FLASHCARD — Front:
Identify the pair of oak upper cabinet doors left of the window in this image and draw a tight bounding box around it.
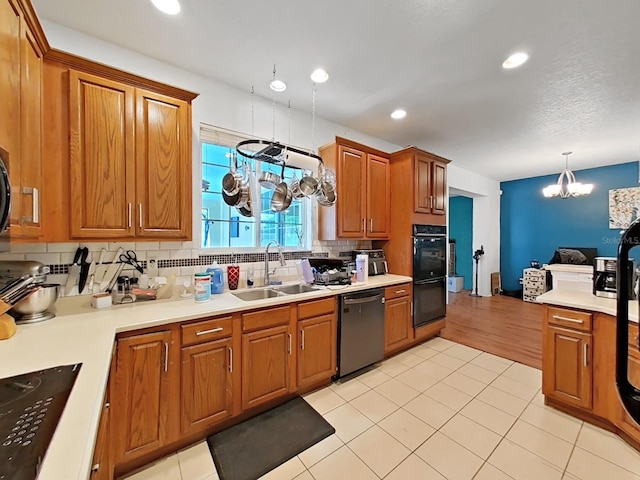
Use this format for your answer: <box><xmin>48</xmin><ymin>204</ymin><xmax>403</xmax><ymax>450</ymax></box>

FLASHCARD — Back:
<box><xmin>69</xmin><ymin>70</ymin><xmax>191</xmax><ymax>239</ymax></box>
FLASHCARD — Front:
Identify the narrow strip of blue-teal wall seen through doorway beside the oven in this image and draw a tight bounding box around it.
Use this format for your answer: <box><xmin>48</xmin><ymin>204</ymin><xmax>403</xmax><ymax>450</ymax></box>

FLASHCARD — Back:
<box><xmin>449</xmin><ymin>197</ymin><xmax>473</xmax><ymax>290</ymax></box>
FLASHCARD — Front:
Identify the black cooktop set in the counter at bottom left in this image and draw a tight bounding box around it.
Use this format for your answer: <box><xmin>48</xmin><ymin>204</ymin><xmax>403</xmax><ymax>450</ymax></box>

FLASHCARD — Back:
<box><xmin>0</xmin><ymin>363</ymin><xmax>82</xmax><ymax>480</ymax></box>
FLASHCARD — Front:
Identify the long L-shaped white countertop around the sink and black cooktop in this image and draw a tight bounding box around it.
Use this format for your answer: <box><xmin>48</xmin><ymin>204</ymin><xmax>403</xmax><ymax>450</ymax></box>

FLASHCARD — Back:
<box><xmin>0</xmin><ymin>274</ymin><xmax>412</xmax><ymax>480</ymax></box>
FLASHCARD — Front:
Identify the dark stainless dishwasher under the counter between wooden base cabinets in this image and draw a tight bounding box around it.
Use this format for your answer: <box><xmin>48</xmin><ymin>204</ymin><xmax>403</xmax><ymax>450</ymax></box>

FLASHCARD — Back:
<box><xmin>338</xmin><ymin>288</ymin><xmax>384</xmax><ymax>377</ymax></box>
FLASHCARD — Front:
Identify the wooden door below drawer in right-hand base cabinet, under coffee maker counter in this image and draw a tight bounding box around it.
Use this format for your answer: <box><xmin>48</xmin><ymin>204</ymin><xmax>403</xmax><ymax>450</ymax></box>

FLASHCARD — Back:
<box><xmin>542</xmin><ymin>326</ymin><xmax>593</xmax><ymax>409</ymax></box>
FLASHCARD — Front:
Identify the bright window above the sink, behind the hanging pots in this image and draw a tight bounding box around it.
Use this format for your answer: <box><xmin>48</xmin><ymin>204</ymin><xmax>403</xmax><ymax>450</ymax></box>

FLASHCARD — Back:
<box><xmin>200</xmin><ymin>125</ymin><xmax>311</xmax><ymax>248</ymax></box>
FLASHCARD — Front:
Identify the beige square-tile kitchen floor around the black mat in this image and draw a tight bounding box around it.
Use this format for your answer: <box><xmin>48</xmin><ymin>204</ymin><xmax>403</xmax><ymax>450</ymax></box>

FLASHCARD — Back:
<box><xmin>121</xmin><ymin>338</ymin><xmax>640</xmax><ymax>480</ymax></box>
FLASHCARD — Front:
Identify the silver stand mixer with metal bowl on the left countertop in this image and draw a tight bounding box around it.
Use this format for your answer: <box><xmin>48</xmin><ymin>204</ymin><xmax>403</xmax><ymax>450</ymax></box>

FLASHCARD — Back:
<box><xmin>0</xmin><ymin>260</ymin><xmax>60</xmax><ymax>323</ymax></box>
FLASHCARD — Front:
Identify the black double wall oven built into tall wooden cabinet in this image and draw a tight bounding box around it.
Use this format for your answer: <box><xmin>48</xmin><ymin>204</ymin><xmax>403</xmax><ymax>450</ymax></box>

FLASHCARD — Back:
<box><xmin>413</xmin><ymin>225</ymin><xmax>447</xmax><ymax>327</ymax></box>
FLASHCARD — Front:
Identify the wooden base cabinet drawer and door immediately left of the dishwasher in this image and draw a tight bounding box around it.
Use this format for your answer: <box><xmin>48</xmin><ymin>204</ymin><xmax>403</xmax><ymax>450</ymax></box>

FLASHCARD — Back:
<box><xmin>297</xmin><ymin>297</ymin><xmax>338</xmax><ymax>389</ymax></box>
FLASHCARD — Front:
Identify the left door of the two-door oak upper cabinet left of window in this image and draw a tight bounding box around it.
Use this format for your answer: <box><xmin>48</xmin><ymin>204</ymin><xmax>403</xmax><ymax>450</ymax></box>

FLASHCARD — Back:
<box><xmin>69</xmin><ymin>70</ymin><xmax>135</xmax><ymax>238</ymax></box>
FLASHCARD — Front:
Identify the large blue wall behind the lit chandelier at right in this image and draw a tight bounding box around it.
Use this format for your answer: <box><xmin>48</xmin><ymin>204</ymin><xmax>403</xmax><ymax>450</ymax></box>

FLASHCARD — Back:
<box><xmin>500</xmin><ymin>162</ymin><xmax>638</xmax><ymax>290</ymax></box>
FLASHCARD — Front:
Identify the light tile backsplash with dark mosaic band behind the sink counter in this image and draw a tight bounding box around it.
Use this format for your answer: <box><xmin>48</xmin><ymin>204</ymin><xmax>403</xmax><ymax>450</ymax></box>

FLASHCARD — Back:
<box><xmin>0</xmin><ymin>240</ymin><xmax>371</xmax><ymax>288</ymax></box>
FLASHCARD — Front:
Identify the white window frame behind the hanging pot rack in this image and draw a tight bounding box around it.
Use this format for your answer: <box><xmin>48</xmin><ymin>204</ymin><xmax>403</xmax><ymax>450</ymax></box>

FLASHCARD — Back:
<box><xmin>199</xmin><ymin>123</ymin><xmax>313</xmax><ymax>255</ymax></box>
